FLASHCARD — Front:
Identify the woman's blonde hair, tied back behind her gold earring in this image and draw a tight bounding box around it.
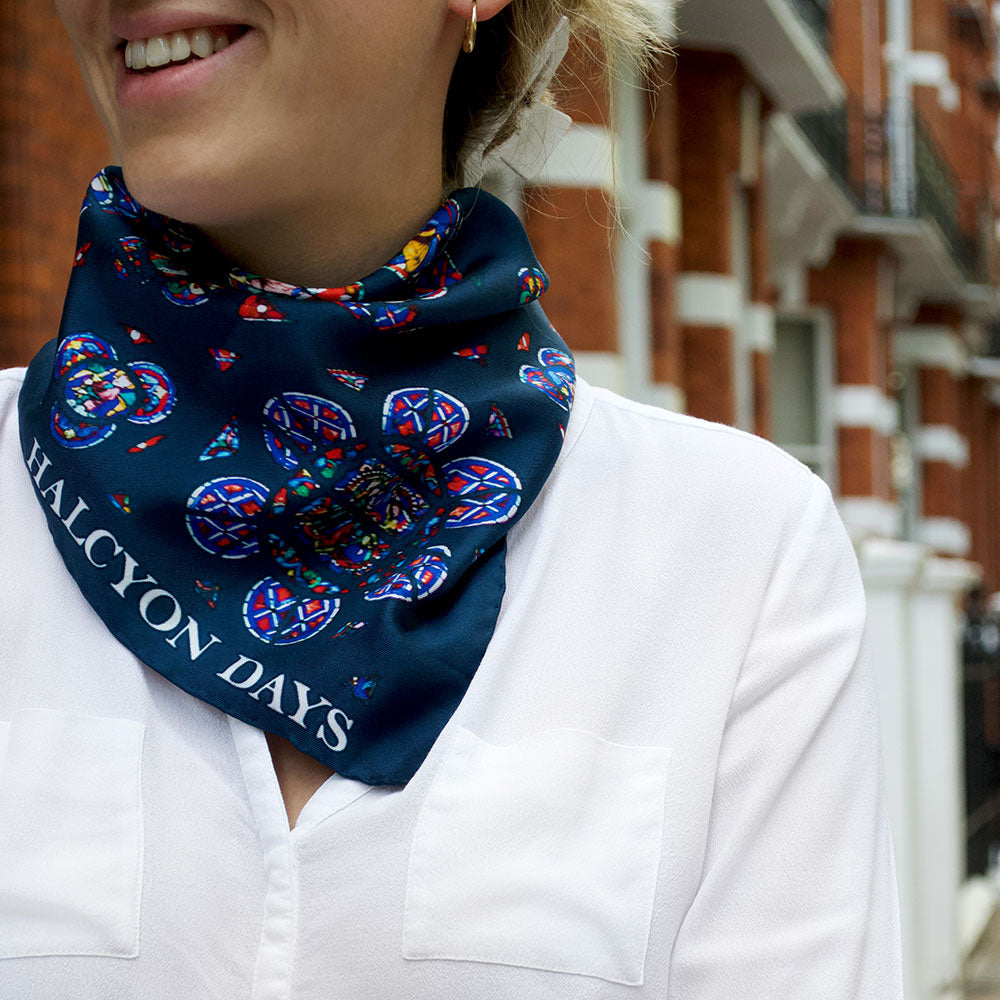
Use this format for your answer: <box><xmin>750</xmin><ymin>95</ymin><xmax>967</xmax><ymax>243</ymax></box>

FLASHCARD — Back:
<box><xmin>443</xmin><ymin>0</ymin><xmax>671</xmax><ymax>188</ymax></box>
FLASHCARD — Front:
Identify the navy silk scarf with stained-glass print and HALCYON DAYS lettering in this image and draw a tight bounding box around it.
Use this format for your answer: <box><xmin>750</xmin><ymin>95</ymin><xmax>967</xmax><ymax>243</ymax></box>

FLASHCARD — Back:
<box><xmin>19</xmin><ymin>167</ymin><xmax>575</xmax><ymax>785</ymax></box>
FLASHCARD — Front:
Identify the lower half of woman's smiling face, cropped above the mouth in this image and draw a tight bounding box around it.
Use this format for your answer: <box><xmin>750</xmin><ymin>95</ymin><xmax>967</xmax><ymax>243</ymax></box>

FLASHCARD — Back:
<box><xmin>56</xmin><ymin>0</ymin><xmax>478</xmax><ymax>226</ymax></box>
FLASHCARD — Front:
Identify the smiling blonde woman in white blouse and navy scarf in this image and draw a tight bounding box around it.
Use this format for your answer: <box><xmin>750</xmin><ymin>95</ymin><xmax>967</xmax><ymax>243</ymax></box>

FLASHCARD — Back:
<box><xmin>0</xmin><ymin>0</ymin><xmax>901</xmax><ymax>1000</ymax></box>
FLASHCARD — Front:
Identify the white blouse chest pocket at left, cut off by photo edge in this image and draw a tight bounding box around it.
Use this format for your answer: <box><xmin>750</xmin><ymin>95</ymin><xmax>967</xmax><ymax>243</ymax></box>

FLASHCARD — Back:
<box><xmin>0</xmin><ymin>709</ymin><xmax>143</xmax><ymax>958</ymax></box>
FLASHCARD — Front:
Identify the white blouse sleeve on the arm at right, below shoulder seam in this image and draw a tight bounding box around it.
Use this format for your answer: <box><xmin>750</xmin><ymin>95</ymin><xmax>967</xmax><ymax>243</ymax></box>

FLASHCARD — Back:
<box><xmin>668</xmin><ymin>479</ymin><xmax>903</xmax><ymax>1000</ymax></box>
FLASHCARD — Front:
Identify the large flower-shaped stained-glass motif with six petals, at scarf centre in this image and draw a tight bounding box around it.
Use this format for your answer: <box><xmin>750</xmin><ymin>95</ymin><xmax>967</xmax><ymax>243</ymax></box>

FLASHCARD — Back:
<box><xmin>187</xmin><ymin>387</ymin><xmax>522</xmax><ymax>645</ymax></box>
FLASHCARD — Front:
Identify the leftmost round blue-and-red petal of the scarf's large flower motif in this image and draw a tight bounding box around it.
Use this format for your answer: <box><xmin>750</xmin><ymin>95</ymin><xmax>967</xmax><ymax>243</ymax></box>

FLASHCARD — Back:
<box><xmin>186</xmin><ymin>476</ymin><xmax>268</xmax><ymax>559</ymax></box>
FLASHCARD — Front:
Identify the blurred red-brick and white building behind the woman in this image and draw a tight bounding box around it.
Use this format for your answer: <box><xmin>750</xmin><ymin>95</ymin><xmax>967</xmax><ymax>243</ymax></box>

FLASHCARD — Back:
<box><xmin>9</xmin><ymin>0</ymin><xmax>1000</xmax><ymax>1000</ymax></box>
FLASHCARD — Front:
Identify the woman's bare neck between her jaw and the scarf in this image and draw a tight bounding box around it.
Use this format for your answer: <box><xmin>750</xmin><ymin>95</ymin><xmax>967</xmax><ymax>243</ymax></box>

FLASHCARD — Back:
<box><xmin>192</xmin><ymin>158</ymin><xmax>446</xmax><ymax>288</ymax></box>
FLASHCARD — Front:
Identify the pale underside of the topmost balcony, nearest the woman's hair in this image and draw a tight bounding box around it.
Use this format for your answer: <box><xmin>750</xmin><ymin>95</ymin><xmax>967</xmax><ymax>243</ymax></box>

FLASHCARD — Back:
<box><xmin>677</xmin><ymin>0</ymin><xmax>844</xmax><ymax>112</ymax></box>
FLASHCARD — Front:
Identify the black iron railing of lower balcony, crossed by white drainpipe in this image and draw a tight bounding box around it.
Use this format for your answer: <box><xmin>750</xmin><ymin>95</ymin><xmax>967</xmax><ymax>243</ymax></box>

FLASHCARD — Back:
<box><xmin>796</xmin><ymin>100</ymin><xmax>986</xmax><ymax>281</ymax></box>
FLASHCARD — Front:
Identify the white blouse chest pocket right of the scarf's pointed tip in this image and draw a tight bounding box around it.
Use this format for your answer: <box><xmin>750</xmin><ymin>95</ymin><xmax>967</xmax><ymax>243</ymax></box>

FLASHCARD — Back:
<box><xmin>403</xmin><ymin>727</ymin><xmax>671</xmax><ymax>985</ymax></box>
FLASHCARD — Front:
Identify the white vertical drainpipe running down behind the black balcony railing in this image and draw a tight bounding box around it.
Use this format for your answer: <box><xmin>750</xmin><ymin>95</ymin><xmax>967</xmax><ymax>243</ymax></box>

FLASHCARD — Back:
<box><xmin>885</xmin><ymin>0</ymin><xmax>916</xmax><ymax>216</ymax></box>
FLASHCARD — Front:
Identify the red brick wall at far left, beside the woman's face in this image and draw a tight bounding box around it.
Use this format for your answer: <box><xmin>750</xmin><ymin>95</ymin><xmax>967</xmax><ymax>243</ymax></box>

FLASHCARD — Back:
<box><xmin>0</xmin><ymin>0</ymin><xmax>110</xmax><ymax>367</ymax></box>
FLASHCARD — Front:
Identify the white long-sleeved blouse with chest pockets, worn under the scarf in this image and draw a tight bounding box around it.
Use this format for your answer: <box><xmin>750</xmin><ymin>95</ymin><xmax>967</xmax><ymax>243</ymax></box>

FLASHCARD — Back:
<box><xmin>0</xmin><ymin>371</ymin><xmax>902</xmax><ymax>1000</ymax></box>
